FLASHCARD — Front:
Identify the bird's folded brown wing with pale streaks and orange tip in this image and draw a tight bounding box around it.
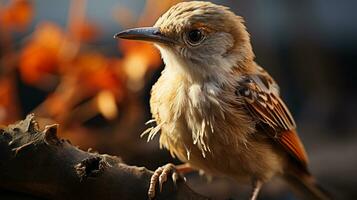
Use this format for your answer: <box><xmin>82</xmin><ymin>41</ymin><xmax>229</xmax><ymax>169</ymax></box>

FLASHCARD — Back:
<box><xmin>236</xmin><ymin>70</ymin><xmax>308</xmax><ymax>168</ymax></box>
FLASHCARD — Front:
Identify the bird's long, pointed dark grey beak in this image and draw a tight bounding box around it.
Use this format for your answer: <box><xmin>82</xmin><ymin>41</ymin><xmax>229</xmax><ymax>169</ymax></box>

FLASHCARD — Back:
<box><xmin>114</xmin><ymin>27</ymin><xmax>176</xmax><ymax>44</ymax></box>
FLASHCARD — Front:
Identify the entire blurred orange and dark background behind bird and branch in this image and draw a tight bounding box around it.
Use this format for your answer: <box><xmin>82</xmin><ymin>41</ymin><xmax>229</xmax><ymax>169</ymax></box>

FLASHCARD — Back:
<box><xmin>0</xmin><ymin>0</ymin><xmax>357</xmax><ymax>199</ymax></box>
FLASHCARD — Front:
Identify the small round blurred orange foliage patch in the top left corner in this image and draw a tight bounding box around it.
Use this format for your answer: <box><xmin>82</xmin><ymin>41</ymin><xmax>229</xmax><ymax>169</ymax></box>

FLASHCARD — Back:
<box><xmin>0</xmin><ymin>0</ymin><xmax>34</xmax><ymax>30</ymax></box>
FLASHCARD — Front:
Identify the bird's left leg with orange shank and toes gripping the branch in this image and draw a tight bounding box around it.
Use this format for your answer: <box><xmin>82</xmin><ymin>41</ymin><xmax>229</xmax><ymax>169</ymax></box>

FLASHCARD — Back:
<box><xmin>148</xmin><ymin>163</ymin><xmax>193</xmax><ymax>199</ymax></box>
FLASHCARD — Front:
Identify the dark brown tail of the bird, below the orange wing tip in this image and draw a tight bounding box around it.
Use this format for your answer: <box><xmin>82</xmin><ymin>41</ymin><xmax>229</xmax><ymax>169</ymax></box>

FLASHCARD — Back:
<box><xmin>284</xmin><ymin>173</ymin><xmax>333</xmax><ymax>200</ymax></box>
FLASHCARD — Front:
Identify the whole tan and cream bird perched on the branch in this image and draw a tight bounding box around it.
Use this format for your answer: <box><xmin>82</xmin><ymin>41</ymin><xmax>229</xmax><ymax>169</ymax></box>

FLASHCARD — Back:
<box><xmin>114</xmin><ymin>1</ymin><xmax>330</xmax><ymax>200</ymax></box>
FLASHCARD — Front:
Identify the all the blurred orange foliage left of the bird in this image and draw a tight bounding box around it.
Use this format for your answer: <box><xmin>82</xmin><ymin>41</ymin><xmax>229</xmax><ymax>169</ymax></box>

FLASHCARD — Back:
<box><xmin>0</xmin><ymin>0</ymin><xmax>172</xmax><ymax>134</ymax></box>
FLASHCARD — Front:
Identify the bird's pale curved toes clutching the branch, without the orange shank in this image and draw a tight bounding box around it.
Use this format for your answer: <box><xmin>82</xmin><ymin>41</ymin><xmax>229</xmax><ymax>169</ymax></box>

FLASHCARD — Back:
<box><xmin>148</xmin><ymin>163</ymin><xmax>181</xmax><ymax>200</ymax></box>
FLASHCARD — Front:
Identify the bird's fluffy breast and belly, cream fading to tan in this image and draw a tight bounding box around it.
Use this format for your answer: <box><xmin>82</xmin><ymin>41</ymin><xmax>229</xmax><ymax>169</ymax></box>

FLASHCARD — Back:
<box><xmin>150</xmin><ymin>72</ymin><xmax>280</xmax><ymax>181</ymax></box>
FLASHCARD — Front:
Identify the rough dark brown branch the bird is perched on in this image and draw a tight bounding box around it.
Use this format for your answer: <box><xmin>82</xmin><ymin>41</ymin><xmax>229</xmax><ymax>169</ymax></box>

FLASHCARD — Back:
<box><xmin>0</xmin><ymin>115</ymin><xmax>207</xmax><ymax>200</ymax></box>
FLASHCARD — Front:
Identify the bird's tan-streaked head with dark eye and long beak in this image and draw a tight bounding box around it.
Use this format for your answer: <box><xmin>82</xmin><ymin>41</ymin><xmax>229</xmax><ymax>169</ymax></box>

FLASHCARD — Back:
<box><xmin>115</xmin><ymin>1</ymin><xmax>254</xmax><ymax>80</ymax></box>
